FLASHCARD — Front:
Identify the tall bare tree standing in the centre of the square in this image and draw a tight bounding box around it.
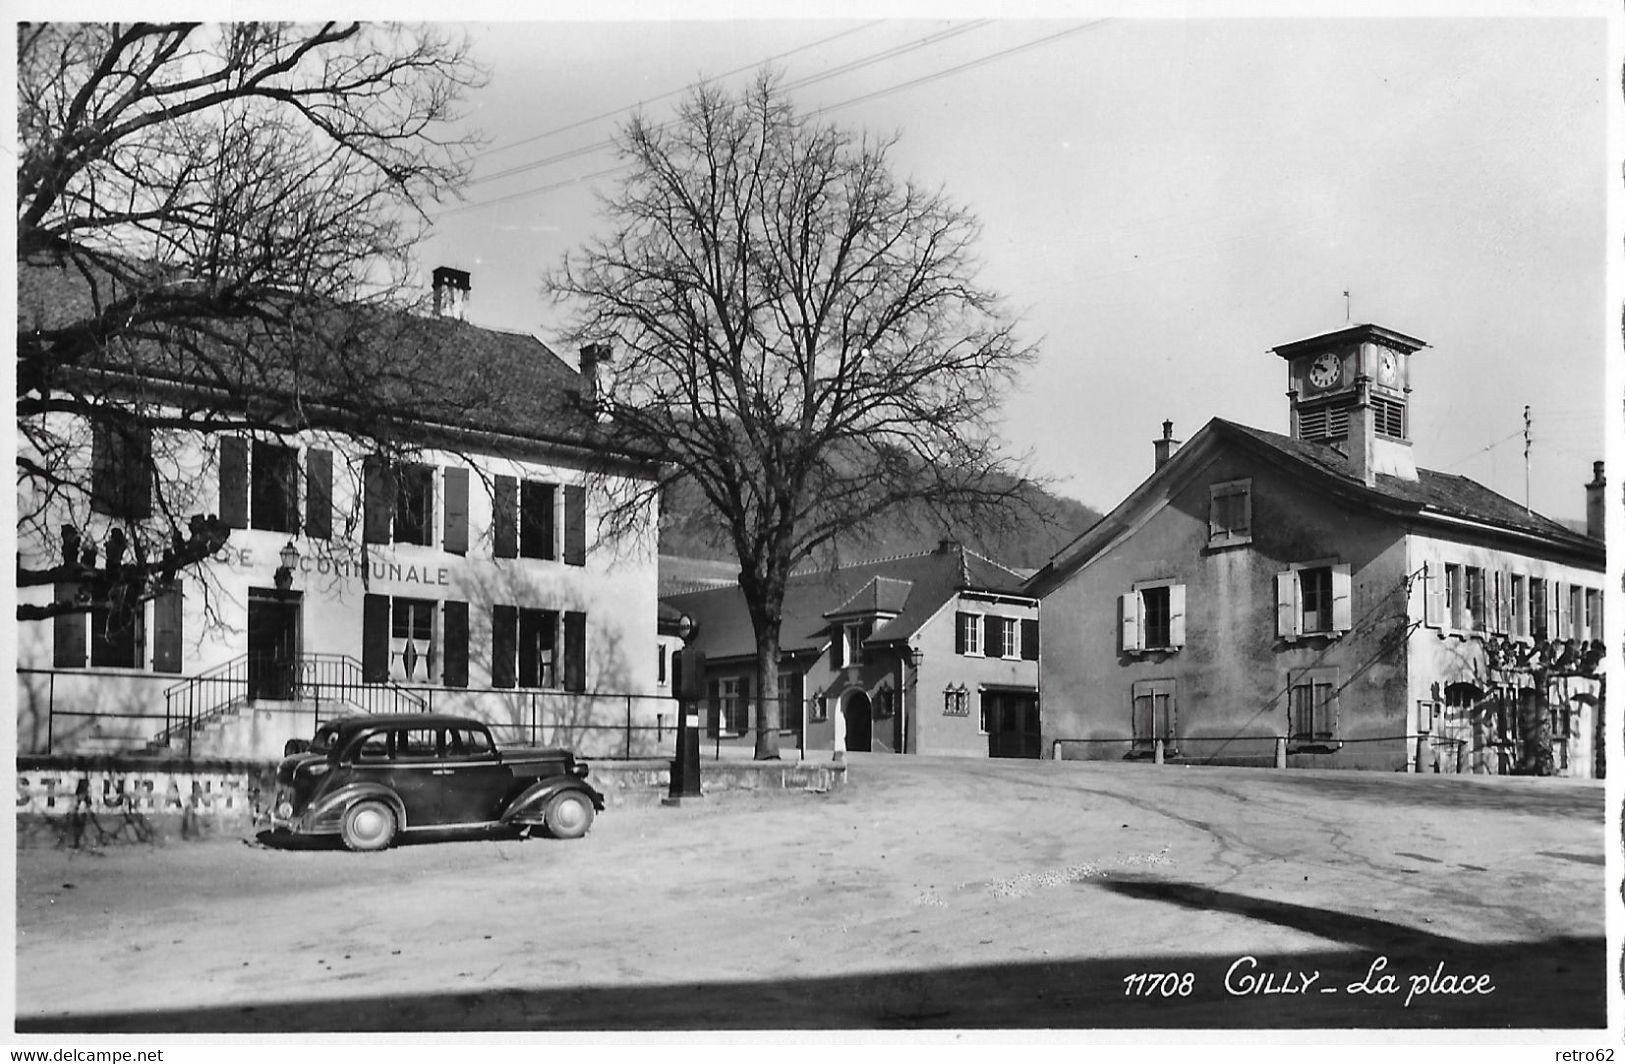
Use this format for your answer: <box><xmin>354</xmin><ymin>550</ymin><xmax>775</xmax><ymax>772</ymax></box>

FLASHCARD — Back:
<box><xmin>548</xmin><ymin>71</ymin><xmax>1032</xmax><ymax>759</ymax></box>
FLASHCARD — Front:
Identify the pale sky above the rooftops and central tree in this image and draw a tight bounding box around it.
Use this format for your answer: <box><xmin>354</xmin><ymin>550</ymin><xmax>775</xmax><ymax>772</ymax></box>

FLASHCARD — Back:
<box><xmin>409</xmin><ymin>3</ymin><xmax>1619</xmax><ymax>518</ymax></box>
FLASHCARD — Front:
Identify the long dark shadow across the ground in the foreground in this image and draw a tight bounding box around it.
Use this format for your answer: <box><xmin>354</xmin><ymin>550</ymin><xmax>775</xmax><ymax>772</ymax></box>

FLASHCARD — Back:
<box><xmin>16</xmin><ymin>879</ymin><xmax>1607</xmax><ymax>1033</ymax></box>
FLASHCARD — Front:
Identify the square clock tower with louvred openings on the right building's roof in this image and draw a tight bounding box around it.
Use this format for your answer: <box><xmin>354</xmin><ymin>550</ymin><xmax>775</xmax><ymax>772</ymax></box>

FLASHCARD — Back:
<box><xmin>1274</xmin><ymin>325</ymin><xmax>1427</xmax><ymax>484</ymax></box>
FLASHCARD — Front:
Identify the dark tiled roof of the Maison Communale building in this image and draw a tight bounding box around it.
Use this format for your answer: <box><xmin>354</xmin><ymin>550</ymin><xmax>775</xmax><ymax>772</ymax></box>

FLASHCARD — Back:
<box><xmin>18</xmin><ymin>253</ymin><xmax>630</xmax><ymax>447</ymax></box>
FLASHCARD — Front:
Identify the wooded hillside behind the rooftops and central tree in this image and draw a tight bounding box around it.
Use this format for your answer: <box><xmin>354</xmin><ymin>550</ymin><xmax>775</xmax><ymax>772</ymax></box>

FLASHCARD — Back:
<box><xmin>660</xmin><ymin>481</ymin><xmax>1102</xmax><ymax>572</ymax></box>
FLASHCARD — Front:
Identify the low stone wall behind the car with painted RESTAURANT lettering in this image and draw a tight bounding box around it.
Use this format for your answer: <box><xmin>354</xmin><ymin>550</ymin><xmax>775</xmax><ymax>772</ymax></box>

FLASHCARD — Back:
<box><xmin>16</xmin><ymin>755</ymin><xmax>847</xmax><ymax>846</ymax></box>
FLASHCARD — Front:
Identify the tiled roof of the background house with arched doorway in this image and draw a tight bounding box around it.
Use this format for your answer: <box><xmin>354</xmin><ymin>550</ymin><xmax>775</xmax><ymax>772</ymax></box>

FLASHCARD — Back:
<box><xmin>663</xmin><ymin>546</ymin><xmax>1022</xmax><ymax>658</ymax></box>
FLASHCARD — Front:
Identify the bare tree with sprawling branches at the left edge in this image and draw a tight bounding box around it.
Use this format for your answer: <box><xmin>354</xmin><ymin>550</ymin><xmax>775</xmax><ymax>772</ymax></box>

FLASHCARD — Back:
<box><xmin>16</xmin><ymin>23</ymin><xmax>483</xmax><ymax>619</ymax></box>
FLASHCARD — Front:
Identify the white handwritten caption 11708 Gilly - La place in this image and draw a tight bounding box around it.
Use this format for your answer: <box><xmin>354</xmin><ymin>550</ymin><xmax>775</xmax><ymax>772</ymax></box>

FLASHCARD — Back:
<box><xmin>1123</xmin><ymin>955</ymin><xmax>1495</xmax><ymax>1009</ymax></box>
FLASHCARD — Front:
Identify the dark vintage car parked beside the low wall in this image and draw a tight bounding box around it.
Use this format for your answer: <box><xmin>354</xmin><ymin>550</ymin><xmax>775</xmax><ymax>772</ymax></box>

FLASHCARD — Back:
<box><xmin>271</xmin><ymin>713</ymin><xmax>605</xmax><ymax>850</ymax></box>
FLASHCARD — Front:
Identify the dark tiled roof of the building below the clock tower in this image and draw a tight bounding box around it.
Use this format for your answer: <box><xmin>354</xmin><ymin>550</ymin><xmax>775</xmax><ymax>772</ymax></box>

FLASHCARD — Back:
<box><xmin>1209</xmin><ymin>417</ymin><xmax>1602</xmax><ymax>549</ymax></box>
